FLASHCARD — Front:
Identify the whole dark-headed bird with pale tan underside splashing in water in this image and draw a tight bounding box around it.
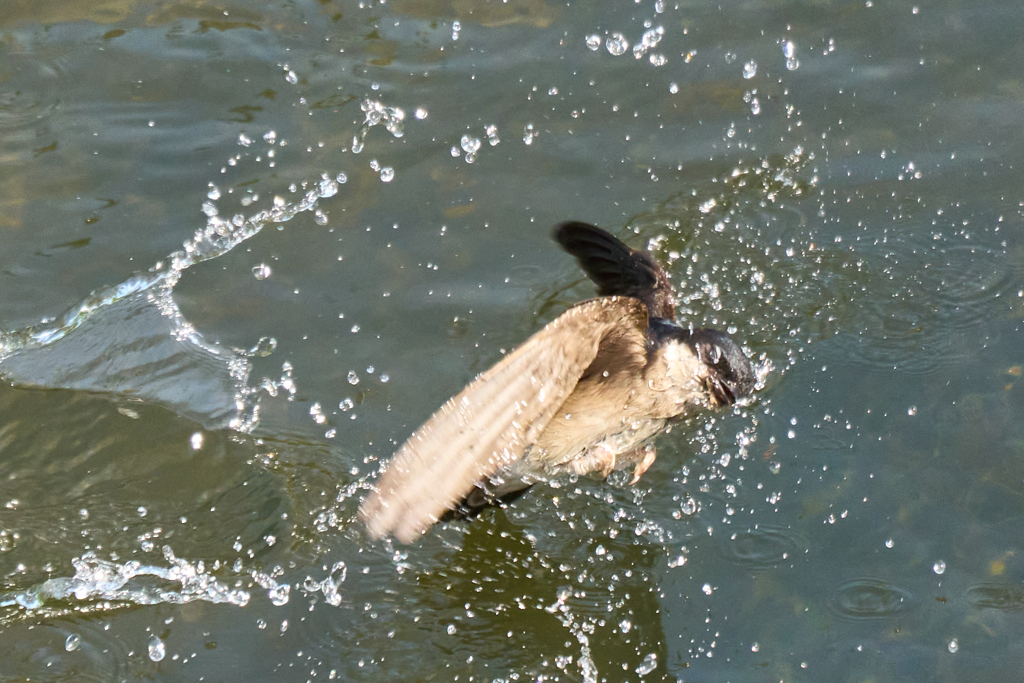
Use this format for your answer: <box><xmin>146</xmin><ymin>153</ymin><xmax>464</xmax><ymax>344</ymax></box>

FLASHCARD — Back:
<box><xmin>359</xmin><ymin>221</ymin><xmax>756</xmax><ymax>544</ymax></box>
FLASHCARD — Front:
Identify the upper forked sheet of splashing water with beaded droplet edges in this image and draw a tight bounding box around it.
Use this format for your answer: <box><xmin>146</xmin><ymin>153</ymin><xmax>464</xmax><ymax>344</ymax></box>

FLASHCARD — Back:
<box><xmin>0</xmin><ymin>164</ymin><xmax>344</xmax><ymax>432</ymax></box>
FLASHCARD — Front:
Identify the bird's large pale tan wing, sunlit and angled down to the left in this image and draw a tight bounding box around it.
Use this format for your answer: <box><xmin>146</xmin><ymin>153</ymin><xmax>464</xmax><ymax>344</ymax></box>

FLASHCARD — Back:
<box><xmin>359</xmin><ymin>297</ymin><xmax>647</xmax><ymax>543</ymax></box>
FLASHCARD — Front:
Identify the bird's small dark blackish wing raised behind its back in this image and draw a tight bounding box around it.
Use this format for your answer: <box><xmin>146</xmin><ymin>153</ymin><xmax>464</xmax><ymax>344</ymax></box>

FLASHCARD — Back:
<box><xmin>554</xmin><ymin>220</ymin><xmax>676</xmax><ymax>321</ymax></box>
